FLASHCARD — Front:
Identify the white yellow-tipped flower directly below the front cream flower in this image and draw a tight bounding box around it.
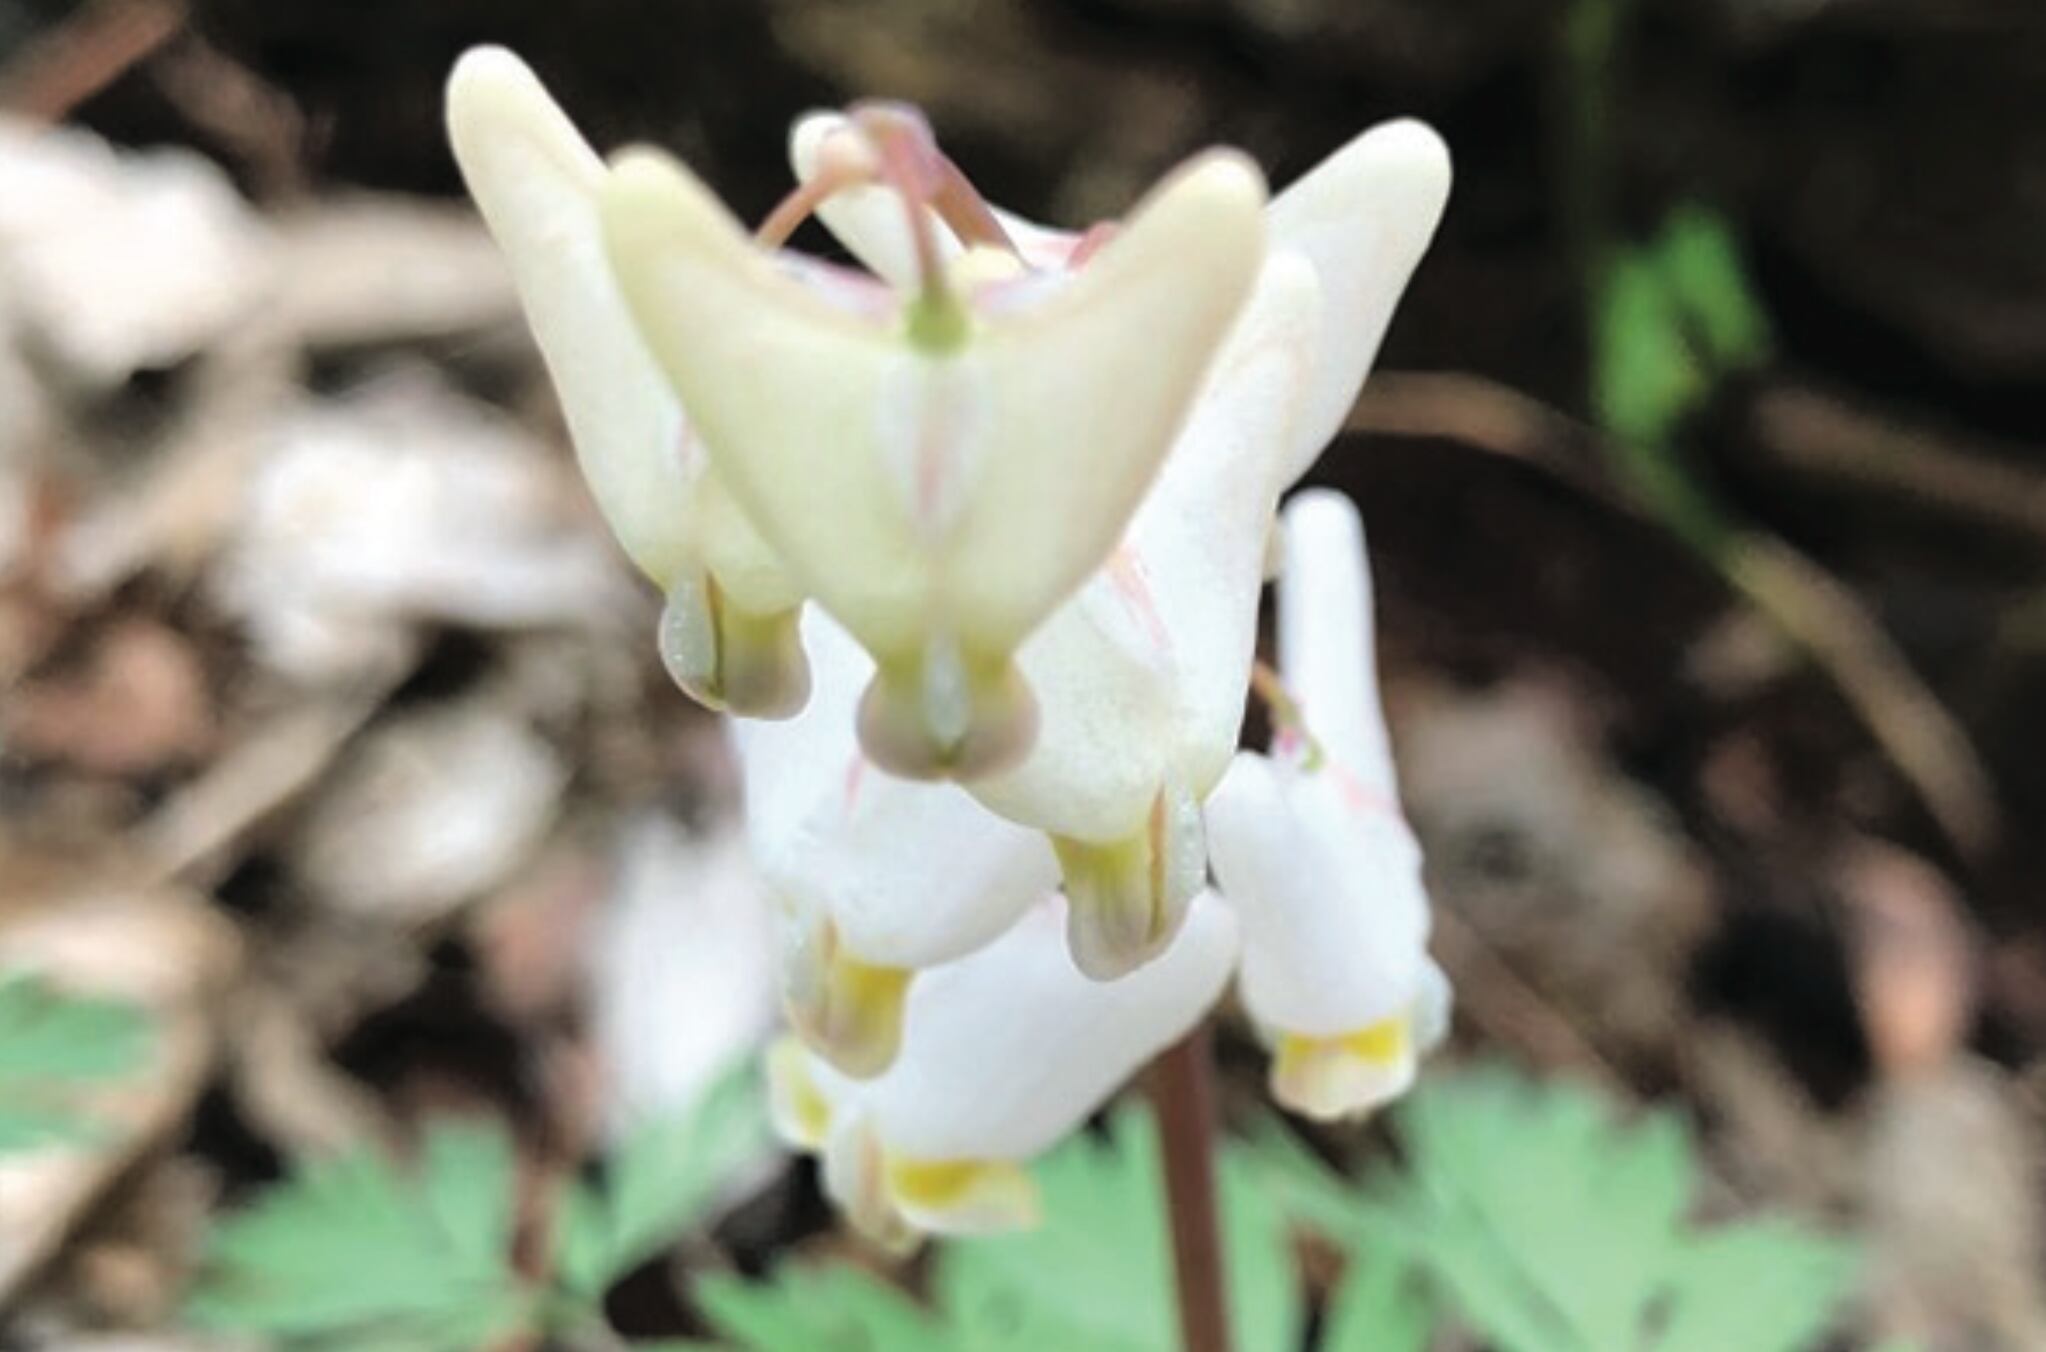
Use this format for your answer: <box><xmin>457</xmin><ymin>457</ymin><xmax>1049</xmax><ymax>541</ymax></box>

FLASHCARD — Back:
<box><xmin>732</xmin><ymin>610</ymin><xmax>1058</xmax><ymax>1076</ymax></box>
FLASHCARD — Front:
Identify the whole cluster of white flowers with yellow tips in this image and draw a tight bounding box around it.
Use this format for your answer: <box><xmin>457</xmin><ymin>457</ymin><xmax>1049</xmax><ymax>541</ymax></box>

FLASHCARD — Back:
<box><xmin>448</xmin><ymin>49</ymin><xmax>1449</xmax><ymax>1242</ymax></box>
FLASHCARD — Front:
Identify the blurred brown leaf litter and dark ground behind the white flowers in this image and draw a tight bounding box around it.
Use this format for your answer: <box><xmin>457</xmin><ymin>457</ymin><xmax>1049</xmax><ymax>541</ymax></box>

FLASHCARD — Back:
<box><xmin>0</xmin><ymin>0</ymin><xmax>2046</xmax><ymax>1352</ymax></box>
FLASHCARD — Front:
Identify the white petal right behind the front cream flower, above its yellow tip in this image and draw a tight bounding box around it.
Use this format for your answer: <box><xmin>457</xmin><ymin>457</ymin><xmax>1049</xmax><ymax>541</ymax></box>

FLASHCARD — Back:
<box><xmin>972</xmin><ymin>256</ymin><xmax>1318</xmax><ymax>841</ymax></box>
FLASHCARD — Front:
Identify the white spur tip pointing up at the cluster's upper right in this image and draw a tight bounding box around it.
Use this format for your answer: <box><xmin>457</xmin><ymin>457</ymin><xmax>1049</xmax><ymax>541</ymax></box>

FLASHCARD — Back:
<box><xmin>1271</xmin><ymin>121</ymin><xmax>1451</xmax><ymax>483</ymax></box>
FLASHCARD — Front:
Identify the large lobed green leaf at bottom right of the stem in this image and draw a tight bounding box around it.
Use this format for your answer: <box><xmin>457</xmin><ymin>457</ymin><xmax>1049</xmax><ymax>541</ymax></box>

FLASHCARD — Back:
<box><xmin>1256</xmin><ymin>1070</ymin><xmax>1854</xmax><ymax>1352</ymax></box>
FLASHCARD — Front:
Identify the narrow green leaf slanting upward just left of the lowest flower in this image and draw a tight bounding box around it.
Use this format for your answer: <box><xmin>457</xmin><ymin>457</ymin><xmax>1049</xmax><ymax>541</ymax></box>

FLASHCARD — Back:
<box><xmin>557</xmin><ymin>1066</ymin><xmax>767</xmax><ymax>1297</ymax></box>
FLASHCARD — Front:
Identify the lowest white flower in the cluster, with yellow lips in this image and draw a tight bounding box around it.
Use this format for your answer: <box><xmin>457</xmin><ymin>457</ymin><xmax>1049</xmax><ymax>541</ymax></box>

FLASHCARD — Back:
<box><xmin>769</xmin><ymin>896</ymin><xmax>1236</xmax><ymax>1246</ymax></box>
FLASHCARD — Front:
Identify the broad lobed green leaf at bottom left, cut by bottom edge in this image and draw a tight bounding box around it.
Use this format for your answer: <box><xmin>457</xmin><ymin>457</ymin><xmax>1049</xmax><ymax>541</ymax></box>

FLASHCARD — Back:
<box><xmin>186</xmin><ymin>1123</ymin><xmax>538</xmax><ymax>1352</ymax></box>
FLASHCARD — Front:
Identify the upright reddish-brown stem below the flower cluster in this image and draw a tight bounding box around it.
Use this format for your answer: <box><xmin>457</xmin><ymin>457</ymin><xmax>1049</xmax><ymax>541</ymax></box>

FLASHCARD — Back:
<box><xmin>1150</xmin><ymin>1025</ymin><xmax>1230</xmax><ymax>1352</ymax></box>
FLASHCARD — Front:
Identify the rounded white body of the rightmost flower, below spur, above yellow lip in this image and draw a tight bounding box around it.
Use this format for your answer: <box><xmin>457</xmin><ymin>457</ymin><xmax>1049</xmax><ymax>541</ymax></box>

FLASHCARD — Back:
<box><xmin>1207</xmin><ymin>753</ymin><xmax>1428</xmax><ymax>1037</ymax></box>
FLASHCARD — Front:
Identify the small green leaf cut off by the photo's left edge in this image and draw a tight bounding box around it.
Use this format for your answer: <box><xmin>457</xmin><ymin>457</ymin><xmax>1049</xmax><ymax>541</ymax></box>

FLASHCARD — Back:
<box><xmin>0</xmin><ymin>974</ymin><xmax>149</xmax><ymax>1154</ymax></box>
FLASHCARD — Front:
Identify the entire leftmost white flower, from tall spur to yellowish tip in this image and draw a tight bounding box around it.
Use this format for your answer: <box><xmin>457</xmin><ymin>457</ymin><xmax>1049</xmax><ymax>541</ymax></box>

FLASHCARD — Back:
<box><xmin>448</xmin><ymin>47</ymin><xmax>808</xmax><ymax>718</ymax></box>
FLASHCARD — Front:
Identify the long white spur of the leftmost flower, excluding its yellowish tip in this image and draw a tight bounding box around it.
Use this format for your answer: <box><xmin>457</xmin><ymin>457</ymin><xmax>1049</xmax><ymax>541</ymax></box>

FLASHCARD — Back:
<box><xmin>448</xmin><ymin>47</ymin><xmax>702</xmax><ymax>587</ymax></box>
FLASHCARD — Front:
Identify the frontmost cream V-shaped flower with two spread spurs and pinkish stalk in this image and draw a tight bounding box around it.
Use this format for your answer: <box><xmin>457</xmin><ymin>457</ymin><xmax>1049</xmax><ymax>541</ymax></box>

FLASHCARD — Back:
<box><xmin>599</xmin><ymin>108</ymin><xmax>1264</xmax><ymax>779</ymax></box>
